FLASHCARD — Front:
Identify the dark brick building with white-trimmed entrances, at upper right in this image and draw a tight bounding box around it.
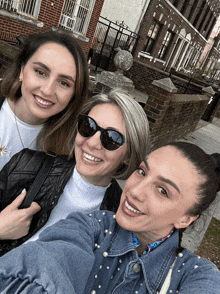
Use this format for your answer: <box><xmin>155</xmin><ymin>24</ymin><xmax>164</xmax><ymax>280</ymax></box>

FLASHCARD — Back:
<box><xmin>135</xmin><ymin>0</ymin><xmax>220</xmax><ymax>72</ymax></box>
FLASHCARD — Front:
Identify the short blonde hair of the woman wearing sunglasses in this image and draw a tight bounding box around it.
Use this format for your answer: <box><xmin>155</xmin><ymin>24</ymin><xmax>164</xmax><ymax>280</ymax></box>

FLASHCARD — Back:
<box><xmin>71</xmin><ymin>89</ymin><xmax>150</xmax><ymax>180</ymax></box>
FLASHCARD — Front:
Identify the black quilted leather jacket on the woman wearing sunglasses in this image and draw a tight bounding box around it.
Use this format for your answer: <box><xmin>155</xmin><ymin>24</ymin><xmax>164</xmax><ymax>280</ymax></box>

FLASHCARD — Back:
<box><xmin>0</xmin><ymin>149</ymin><xmax>122</xmax><ymax>256</ymax></box>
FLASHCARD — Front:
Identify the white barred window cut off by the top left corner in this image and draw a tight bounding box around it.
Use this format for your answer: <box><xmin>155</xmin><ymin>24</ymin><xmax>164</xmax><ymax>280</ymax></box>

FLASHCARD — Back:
<box><xmin>0</xmin><ymin>0</ymin><xmax>41</xmax><ymax>18</ymax></box>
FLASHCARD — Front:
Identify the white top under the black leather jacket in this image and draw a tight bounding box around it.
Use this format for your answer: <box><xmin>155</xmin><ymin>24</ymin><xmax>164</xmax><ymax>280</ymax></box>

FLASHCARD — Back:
<box><xmin>25</xmin><ymin>168</ymin><xmax>111</xmax><ymax>243</ymax></box>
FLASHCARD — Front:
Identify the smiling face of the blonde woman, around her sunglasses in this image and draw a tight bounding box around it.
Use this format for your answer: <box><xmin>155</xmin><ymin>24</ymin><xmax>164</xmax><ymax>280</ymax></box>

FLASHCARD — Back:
<box><xmin>75</xmin><ymin>103</ymin><xmax>127</xmax><ymax>187</ymax></box>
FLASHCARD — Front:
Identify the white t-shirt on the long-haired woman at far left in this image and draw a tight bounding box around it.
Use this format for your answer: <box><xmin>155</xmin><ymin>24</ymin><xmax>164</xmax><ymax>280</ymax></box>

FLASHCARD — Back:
<box><xmin>0</xmin><ymin>99</ymin><xmax>43</xmax><ymax>170</ymax></box>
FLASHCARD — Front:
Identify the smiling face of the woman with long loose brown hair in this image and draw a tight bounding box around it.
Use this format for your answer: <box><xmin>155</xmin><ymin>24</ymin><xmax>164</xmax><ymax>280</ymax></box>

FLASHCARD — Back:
<box><xmin>15</xmin><ymin>43</ymin><xmax>76</xmax><ymax>124</ymax></box>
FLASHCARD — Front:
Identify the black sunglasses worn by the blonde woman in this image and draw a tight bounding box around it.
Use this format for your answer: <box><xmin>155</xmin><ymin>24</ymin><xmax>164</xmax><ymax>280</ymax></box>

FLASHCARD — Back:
<box><xmin>78</xmin><ymin>114</ymin><xmax>125</xmax><ymax>151</ymax></box>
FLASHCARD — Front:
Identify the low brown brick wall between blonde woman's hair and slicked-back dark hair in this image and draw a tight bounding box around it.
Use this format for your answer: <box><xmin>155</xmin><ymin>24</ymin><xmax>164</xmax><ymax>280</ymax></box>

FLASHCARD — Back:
<box><xmin>144</xmin><ymin>78</ymin><xmax>210</xmax><ymax>150</ymax></box>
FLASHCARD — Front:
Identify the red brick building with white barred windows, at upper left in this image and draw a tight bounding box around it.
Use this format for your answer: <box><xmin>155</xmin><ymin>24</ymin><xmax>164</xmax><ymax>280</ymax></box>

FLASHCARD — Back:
<box><xmin>0</xmin><ymin>0</ymin><xmax>104</xmax><ymax>53</ymax></box>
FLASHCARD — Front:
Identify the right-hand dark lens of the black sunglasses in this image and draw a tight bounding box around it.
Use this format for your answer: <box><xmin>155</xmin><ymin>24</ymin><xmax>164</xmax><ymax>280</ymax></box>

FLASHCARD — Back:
<box><xmin>101</xmin><ymin>130</ymin><xmax>124</xmax><ymax>150</ymax></box>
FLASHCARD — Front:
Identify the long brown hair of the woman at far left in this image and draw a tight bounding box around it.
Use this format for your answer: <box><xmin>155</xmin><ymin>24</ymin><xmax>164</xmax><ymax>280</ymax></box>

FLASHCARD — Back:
<box><xmin>1</xmin><ymin>31</ymin><xmax>89</xmax><ymax>155</ymax></box>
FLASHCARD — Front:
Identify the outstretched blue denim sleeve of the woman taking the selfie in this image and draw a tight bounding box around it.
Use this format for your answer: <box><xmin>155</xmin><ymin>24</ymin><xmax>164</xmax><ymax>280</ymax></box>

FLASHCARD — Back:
<box><xmin>0</xmin><ymin>213</ymin><xmax>99</xmax><ymax>294</ymax></box>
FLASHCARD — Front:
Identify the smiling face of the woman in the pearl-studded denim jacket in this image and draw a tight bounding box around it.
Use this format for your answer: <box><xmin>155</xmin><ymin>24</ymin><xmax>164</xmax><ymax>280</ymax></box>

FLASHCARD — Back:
<box><xmin>116</xmin><ymin>146</ymin><xmax>204</xmax><ymax>245</ymax></box>
